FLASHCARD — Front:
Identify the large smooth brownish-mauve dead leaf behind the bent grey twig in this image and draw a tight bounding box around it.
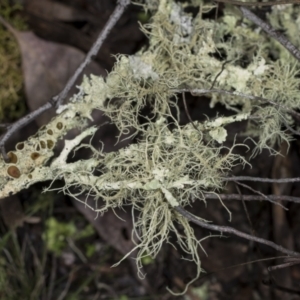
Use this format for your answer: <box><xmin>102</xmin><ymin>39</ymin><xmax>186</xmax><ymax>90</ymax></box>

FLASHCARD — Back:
<box><xmin>0</xmin><ymin>20</ymin><xmax>106</xmax><ymax>125</ymax></box>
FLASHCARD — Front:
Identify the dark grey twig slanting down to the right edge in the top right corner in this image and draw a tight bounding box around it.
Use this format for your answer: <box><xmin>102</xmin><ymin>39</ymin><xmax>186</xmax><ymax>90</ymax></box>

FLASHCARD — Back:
<box><xmin>240</xmin><ymin>6</ymin><xmax>300</xmax><ymax>61</ymax></box>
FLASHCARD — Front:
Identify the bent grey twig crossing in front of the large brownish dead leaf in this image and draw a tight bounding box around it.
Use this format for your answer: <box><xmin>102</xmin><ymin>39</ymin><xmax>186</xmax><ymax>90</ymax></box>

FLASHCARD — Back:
<box><xmin>0</xmin><ymin>0</ymin><xmax>130</xmax><ymax>162</ymax></box>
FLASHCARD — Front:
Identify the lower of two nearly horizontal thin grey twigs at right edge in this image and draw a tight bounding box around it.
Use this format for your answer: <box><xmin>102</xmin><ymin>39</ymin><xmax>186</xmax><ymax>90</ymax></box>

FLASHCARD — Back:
<box><xmin>204</xmin><ymin>193</ymin><xmax>300</xmax><ymax>203</ymax></box>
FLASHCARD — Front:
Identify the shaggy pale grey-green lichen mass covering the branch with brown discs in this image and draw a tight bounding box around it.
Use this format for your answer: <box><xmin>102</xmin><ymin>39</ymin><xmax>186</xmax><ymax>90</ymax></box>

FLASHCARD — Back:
<box><xmin>0</xmin><ymin>0</ymin><xmax>300</xmax><ymax>296</ymax></box>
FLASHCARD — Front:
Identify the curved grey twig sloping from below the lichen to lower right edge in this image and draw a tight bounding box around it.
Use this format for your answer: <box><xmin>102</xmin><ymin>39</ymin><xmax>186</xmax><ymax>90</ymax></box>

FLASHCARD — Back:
<box><xmin>174</xmin><ymin>205</ymin><xmax>300</xmax><ymax>257</ymax></box>
